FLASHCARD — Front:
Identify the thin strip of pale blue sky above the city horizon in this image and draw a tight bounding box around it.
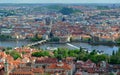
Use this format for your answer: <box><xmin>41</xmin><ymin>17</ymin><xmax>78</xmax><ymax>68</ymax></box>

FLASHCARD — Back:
<box><xmin>0</xmin><ymin>0</ymin><xmax>120</xmax><ymax>3</ymax></box>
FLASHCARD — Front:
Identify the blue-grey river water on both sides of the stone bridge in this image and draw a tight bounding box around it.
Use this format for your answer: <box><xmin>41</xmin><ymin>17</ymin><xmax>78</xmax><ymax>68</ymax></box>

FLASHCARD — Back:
<box><xmin>0</xmin><ymin>41</ymin><xmax>118</xmax><ymax>54</ymax></box>
